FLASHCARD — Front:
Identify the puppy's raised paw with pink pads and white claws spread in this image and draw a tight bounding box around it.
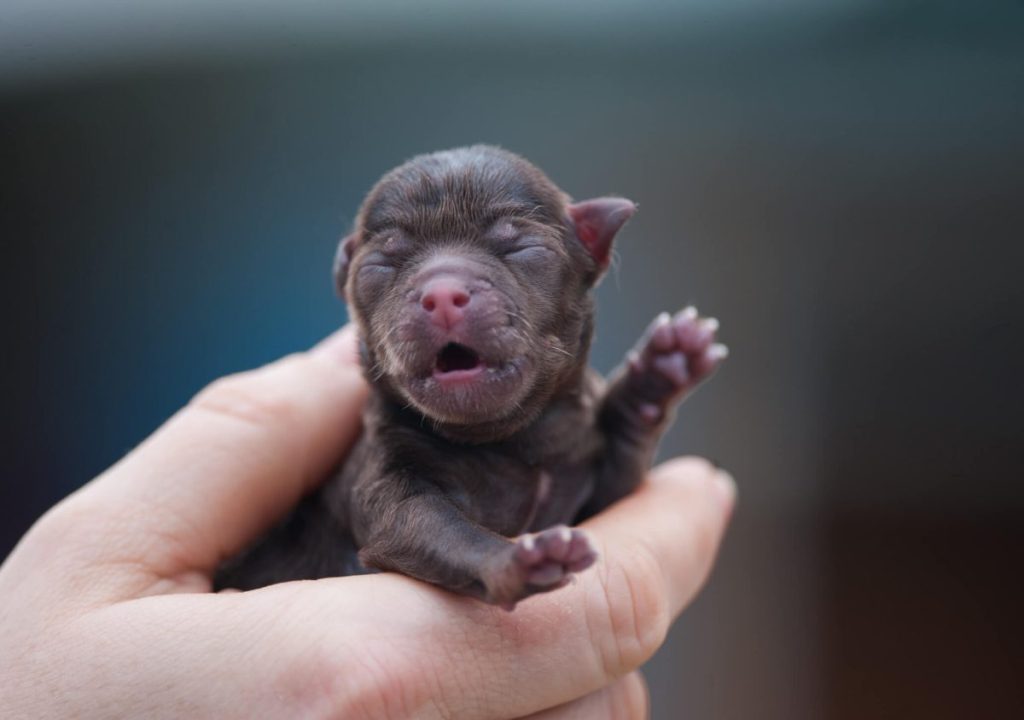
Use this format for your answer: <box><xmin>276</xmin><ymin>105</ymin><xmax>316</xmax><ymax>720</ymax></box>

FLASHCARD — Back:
<box><xmin>628</xmin><ymin>306</ymin><xmax>729</xmax><ymax>413</ymax></box>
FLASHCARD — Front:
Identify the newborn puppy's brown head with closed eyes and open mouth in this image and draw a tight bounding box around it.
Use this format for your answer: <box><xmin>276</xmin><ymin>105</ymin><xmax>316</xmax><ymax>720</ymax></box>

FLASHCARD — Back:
<box><xmin>335</xmin><ymin>145</ymin><xmax>635</xmax><ymax>439</ymax></box>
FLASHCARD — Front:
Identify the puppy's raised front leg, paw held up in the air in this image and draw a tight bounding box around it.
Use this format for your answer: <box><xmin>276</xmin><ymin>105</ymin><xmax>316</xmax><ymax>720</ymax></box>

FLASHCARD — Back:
<box><xmin>584</xmin><ymin>307</ymin><xmax>728</xmax><ymax>516</ymax></box>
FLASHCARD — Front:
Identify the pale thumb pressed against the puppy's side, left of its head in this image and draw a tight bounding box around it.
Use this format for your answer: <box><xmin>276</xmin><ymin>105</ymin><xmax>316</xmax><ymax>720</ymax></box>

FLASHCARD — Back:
<box><xmin>33</xmin><ymin>329</ymin><xmax>366</xmax><ymax>575</ymax></box>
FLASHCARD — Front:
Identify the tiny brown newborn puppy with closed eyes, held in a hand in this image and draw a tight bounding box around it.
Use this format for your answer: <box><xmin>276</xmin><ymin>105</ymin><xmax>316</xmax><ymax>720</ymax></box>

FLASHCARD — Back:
<box><xmin>217</xmin><ymin>145</ymin><xmax>726</xmax><ymax>608</ymax></box>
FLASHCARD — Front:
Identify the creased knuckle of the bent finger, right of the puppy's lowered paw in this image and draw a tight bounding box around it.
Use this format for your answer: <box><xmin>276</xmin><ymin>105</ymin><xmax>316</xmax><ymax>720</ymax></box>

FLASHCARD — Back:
<box><xmin>598</xmin><ymin>548</ymin><xmax>672</xmax><ymax>678</ymax></box>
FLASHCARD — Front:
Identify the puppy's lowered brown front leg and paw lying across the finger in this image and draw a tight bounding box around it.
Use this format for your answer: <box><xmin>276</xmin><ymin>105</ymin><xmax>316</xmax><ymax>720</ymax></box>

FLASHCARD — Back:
<box><xmin>359</xmin><ymin>491</ymin><xmax>597</xmax><ymax>609</ymax></box>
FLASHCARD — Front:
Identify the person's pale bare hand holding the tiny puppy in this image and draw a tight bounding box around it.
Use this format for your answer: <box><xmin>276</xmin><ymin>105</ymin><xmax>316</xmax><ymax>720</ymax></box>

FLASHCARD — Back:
<box><xmin>0</xmin><ymin>330</ymin><xmax>735</xmax><ymax>720</ymax></box>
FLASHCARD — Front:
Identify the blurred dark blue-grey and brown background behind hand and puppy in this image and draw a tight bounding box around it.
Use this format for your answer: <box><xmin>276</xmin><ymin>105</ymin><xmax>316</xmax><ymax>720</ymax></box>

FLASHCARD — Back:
<box><xmin>0</xmin><ymin>0</ymin><xmax>1024</xmax><ymax>720</ymax></box>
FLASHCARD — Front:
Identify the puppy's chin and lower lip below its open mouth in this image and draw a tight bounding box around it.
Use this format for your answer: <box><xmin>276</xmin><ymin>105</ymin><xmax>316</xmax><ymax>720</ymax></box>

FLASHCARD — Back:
<box><xmin>392</xmin><ymin>348</ymin><xmax>536</xmax><ymax>426</ymax></box>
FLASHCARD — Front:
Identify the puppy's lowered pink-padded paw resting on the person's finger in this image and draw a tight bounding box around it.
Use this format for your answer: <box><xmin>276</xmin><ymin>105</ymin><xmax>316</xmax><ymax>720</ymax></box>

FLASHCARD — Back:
<box><xmin>485</xmin><ymin>525</ymin><xmax>597</xmax><ymax>609</ymax></box>
